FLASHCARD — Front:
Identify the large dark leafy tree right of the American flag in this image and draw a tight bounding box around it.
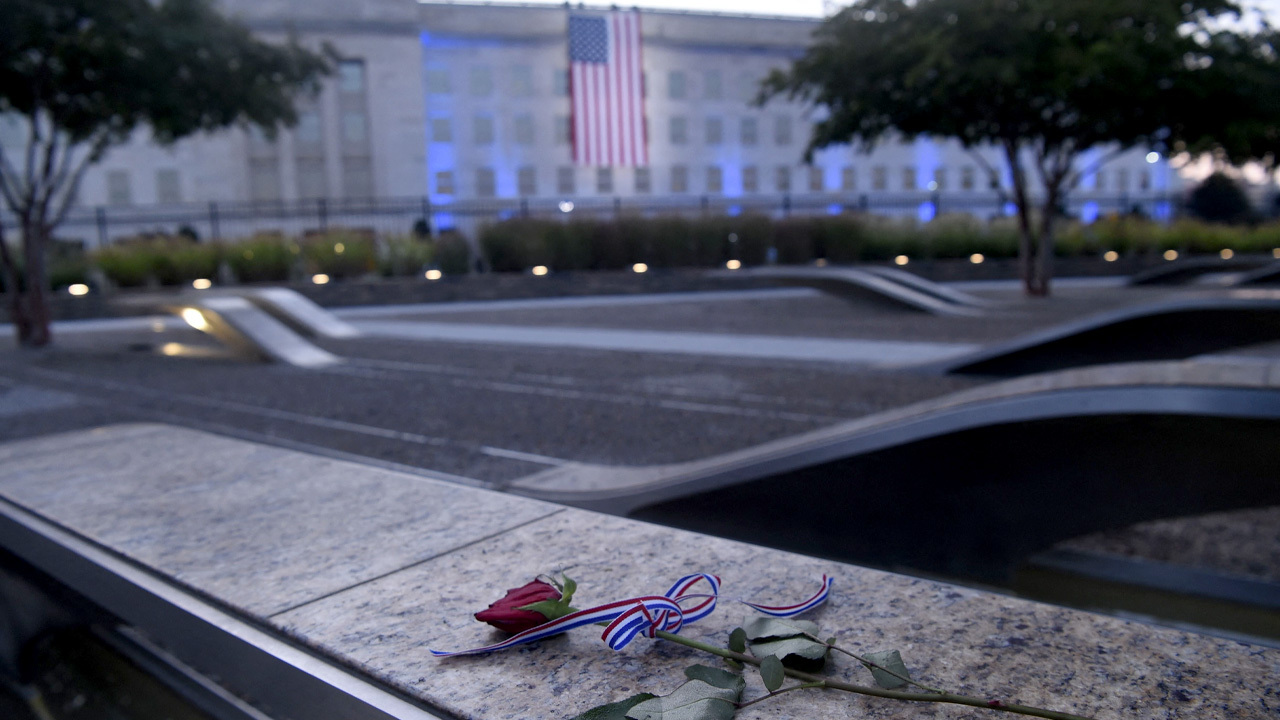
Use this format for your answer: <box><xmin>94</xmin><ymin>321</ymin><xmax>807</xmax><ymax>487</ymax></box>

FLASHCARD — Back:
<box><xmin>759</xmin><ymin>0</ymin><xmax>1280</xmax><ymax>296</ymax></box>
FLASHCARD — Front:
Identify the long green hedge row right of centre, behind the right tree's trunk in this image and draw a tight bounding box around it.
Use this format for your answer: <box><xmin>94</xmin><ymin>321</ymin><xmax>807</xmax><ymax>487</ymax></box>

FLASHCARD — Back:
<box><xmin>480</xmin><ymin>214</ymin><xmax>1280</xmax><ymax>272</ymax></box>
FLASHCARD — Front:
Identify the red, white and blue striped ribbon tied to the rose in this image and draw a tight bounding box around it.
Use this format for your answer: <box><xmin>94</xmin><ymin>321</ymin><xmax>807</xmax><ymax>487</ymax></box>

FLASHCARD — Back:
<box><xmin>430</xmin><ymin>573</ymin><xmax>832</xmax><ymax>657</ymax></box>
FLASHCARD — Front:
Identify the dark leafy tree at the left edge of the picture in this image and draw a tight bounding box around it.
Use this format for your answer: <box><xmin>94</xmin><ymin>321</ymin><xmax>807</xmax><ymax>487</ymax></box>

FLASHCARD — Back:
<box><xmin>0</xmin><ymin>0</ymin><xmax>330</xmax><ymax>346</ymax></box>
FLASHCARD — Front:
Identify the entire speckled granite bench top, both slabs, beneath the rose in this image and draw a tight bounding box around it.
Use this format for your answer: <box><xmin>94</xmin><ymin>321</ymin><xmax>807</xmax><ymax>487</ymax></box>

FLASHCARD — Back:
<box><xmin>0</xmin><ymin>425</ymin><xmax>1280</xmax><ymax>720</ymax></box>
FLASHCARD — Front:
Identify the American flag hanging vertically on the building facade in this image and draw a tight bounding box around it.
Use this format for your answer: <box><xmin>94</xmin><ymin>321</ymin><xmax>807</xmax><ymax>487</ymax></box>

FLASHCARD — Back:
<box><xmin>568</xmin><ymin>10</ymin><xmax>649</xmax><ymax>167</ymax></box>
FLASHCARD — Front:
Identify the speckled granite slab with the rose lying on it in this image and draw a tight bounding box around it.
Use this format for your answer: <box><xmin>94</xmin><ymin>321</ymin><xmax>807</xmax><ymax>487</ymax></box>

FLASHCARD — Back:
<box><xmin>273</xmin><ymin>510</ymin><xmax>1280</xmax><ymax>720</ymax></box>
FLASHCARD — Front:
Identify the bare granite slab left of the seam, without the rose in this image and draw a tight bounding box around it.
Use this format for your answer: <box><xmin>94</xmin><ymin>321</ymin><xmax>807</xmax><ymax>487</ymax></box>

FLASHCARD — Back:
<box><xmin>0</xmin><ymin>425</ymin><xmax>557</xmax><ymax>614</ymax></box>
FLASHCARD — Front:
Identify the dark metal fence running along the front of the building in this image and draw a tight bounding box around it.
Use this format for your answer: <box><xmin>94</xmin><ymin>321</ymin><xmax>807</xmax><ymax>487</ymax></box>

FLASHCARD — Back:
<box><xmin>20</xmin><ymin>192</ymin><xmax>1180</xmax><ymax>247</ymax></box>
